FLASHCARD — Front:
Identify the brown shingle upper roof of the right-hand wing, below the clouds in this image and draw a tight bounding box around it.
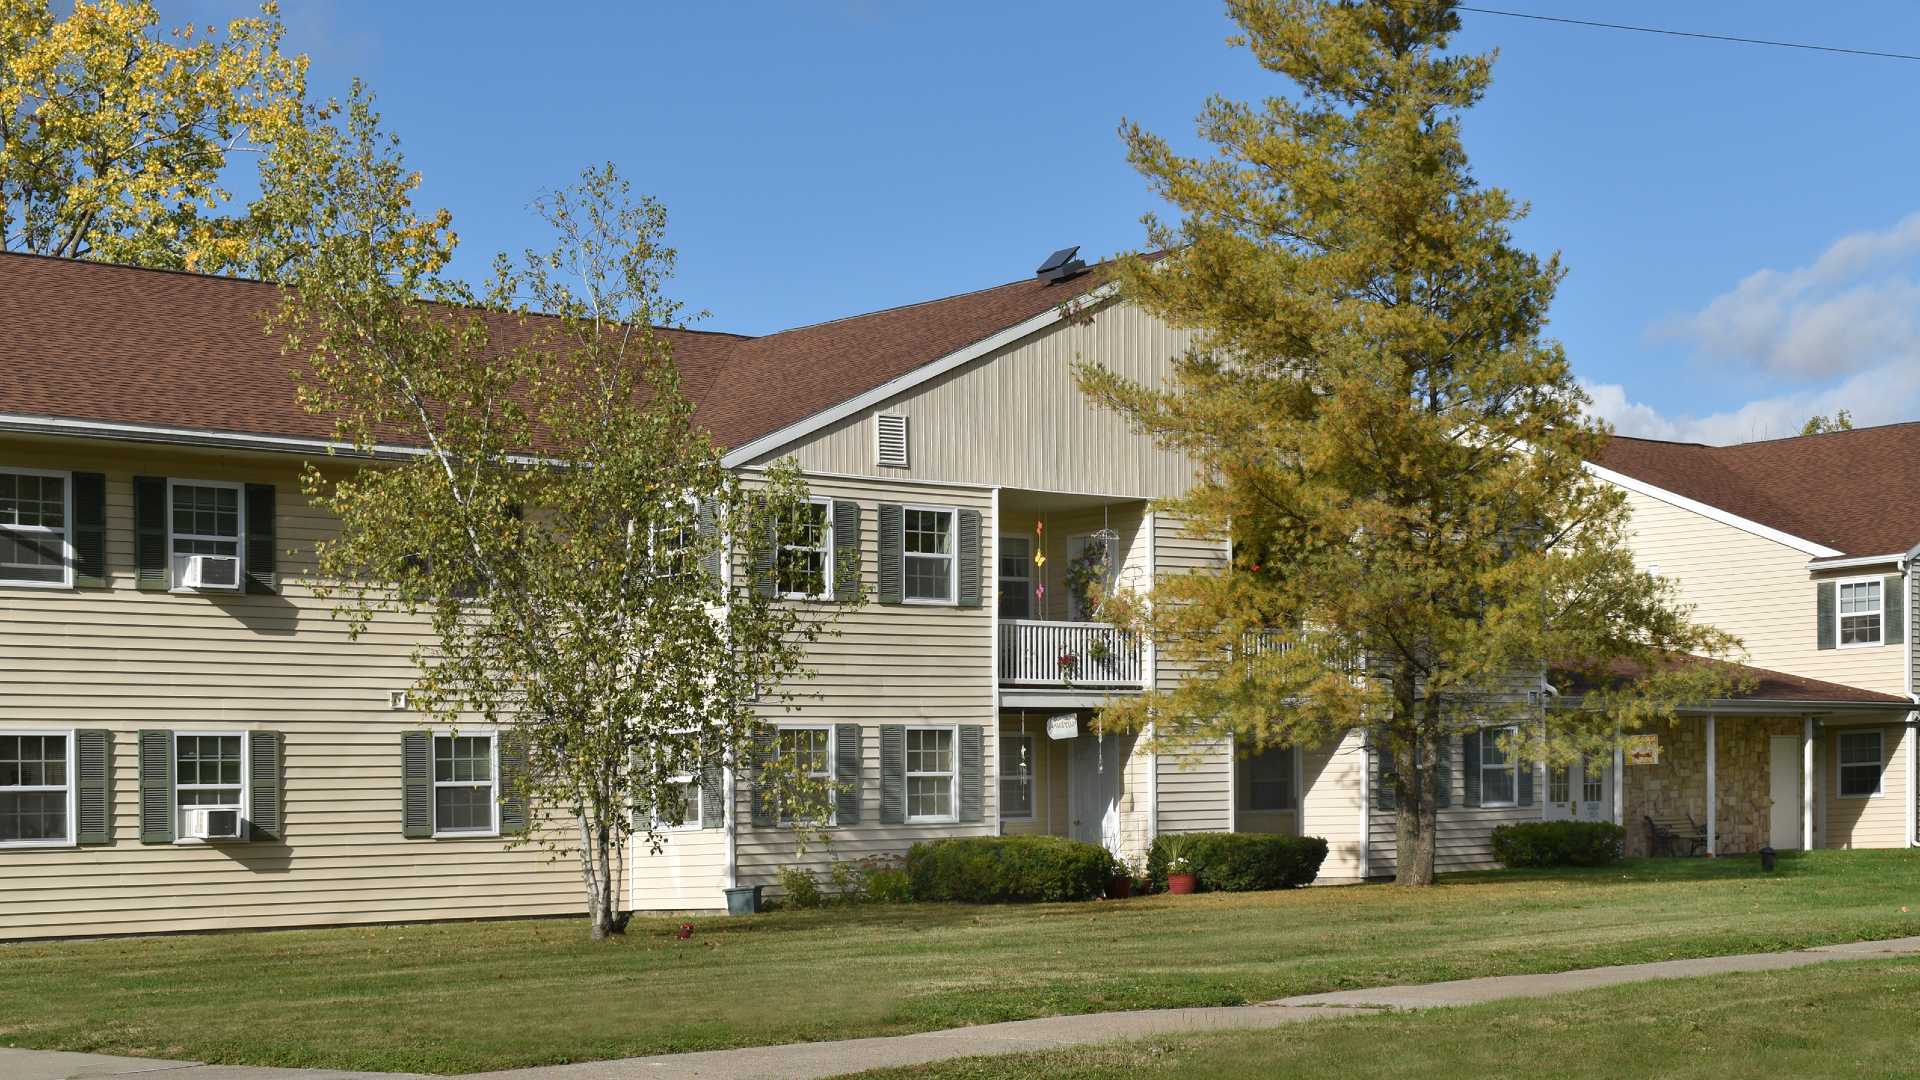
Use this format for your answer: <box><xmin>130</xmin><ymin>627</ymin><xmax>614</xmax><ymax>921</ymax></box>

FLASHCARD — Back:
<box><xmin>1594</xmin><ymin>423</ymin><xmax>1920</xmax><ymax>555</ymax></box>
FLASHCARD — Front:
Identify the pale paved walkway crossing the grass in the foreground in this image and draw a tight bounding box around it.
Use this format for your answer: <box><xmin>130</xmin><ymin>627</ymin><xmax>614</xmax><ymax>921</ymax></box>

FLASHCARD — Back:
<box><xmin>15</xmin><ymin>938</ymin><xmax>1920</xmax><ymax>1080</ymax></box>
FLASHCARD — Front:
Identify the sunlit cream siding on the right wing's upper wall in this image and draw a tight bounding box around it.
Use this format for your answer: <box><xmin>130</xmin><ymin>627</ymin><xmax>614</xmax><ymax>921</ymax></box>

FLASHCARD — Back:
<box><xmin>1626</xmin><ymin>492</ymin><xmax>1912</xmax><ymax>694</ymax></box>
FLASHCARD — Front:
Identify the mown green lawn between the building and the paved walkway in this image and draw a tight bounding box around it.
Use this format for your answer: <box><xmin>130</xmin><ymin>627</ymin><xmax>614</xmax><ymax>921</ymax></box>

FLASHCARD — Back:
<box><xmin>0</xmin><ymin>851</ymin><xmax>1920</xmax><ymax>1072</ymax></box>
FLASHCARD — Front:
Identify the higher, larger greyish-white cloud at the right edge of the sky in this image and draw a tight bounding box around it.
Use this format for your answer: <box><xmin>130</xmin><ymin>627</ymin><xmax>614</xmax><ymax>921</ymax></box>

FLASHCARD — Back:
<box><xmin>1651</xmin><ymin>213</ymin><xmax>1920</xmax><ymax>380</ymax></box>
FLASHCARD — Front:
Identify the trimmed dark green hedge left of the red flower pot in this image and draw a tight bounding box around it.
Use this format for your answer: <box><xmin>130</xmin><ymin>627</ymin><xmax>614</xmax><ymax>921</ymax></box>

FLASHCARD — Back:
<box><xmin>906</xmin><ymin>836</ymin><xmax>1117</xmax><ymax>903</ymax></box>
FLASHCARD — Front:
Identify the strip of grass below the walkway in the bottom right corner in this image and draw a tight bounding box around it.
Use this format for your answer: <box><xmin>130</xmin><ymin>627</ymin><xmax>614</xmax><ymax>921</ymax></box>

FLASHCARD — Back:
<box><xmin>860</xmin><ymin>959</ymin><xmax>1920</xmax><ymax>1080</ymax></box>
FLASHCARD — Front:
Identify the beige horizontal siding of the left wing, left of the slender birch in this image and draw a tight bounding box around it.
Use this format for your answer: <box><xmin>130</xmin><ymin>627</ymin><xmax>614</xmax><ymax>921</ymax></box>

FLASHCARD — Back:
<box><xmin>0</xmin><ymin>440</ymin><xmax>582</xmax><ymax>938</ymax></box>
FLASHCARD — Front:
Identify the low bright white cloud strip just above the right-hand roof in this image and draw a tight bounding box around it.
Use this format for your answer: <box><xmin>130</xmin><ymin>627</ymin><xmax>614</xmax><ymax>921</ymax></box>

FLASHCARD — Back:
<box><xmin>1584</xmin><ymin>359</ymin><xmax>1920</xmax><ymax>444</ymax></box>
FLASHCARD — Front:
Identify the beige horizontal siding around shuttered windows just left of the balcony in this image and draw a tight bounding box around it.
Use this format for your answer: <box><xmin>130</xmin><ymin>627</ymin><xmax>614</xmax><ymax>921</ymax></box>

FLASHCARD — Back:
<box><xmin>733</xmin><ymin>477</ymin><xmax>1000</xmax><ymax>886</ymax></box>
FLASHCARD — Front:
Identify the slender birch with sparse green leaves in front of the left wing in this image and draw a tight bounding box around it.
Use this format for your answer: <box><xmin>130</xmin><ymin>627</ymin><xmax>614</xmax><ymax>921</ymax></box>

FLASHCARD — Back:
<box><xmin>269</xmin><ymin>151</ymin><xmax>831</xmax><ymax>938</ymax></box>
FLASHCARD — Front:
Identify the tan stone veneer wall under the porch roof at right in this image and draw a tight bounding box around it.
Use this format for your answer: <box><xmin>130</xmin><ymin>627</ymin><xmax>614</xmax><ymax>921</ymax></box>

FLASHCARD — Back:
<box><xmin>1626</xmin><ymin>717</ymin><xmax>1803</xmax><ymax>855</ymax></box>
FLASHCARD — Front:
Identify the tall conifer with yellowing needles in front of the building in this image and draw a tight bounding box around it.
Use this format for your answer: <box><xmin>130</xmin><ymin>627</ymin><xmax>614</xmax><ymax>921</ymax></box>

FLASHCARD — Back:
<box><xmin>1081</xmin><ymin>0</ymin><xmax>1738</xmax><ymax>884</ymax></box>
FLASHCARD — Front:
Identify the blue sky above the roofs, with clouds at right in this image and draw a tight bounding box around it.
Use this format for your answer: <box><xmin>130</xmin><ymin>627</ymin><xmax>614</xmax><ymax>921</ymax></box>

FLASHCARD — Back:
<box><xmin>176</xmin><ymin>0</ymin><xmax>1920</xmax><ymax>442</ymax></box>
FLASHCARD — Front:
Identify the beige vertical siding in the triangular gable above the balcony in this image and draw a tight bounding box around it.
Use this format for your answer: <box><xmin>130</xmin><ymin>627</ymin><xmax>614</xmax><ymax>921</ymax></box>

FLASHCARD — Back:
<box><xmin>758</xmin><ymin>294</ymin><xmax>1194</xmax><ymax>498</ymax></box>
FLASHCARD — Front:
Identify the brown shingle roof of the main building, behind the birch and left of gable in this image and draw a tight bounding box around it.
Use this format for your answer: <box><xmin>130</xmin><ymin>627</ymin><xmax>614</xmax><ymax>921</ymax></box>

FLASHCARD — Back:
<box><xmin>0</xmin><ymin>254</ymin><xmax>1098</xmax><ymax>446</ymax></box>
